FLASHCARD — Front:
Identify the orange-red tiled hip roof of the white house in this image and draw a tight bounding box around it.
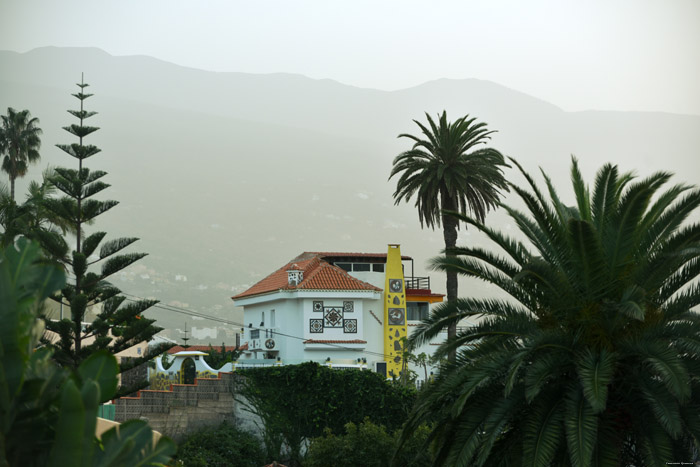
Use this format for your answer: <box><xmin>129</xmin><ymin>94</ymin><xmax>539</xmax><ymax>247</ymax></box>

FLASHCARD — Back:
<box><xmin>231</xmin><ymin>253</ymin><xmax>386</xmax><ymax>300</ymax></box>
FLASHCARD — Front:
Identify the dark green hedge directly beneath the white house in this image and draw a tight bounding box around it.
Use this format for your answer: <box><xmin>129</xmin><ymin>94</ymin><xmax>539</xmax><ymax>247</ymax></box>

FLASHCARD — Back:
<box><xmin>240</xmin><ymin>362</ymin><xmax>415</xmax><ymax>462</ymax></box>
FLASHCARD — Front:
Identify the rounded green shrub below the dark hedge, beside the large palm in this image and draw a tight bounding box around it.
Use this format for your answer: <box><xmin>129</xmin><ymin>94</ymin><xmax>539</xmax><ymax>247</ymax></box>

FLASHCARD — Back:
<box><xmin>304</xmin><ymin>418</ymin><xmax>432</xmax><ymax>467</ymax></box>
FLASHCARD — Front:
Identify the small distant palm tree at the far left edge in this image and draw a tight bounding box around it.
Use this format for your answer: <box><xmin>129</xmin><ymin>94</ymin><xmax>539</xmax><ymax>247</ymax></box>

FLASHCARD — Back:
<box><xmin>0</xmin><ymin>107</ymin><xmax>41</xmax><ymax>201</ymax></box>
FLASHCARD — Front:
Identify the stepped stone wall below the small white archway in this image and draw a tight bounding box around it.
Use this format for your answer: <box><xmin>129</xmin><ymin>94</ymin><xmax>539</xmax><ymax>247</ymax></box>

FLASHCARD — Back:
<box><xmin>115</xmin><ymin>373</ymin><xmax>246</xmax><ymax>440</ymax></box>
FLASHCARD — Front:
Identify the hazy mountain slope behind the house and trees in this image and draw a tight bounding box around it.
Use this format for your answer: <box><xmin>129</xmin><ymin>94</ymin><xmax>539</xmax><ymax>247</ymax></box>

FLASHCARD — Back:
<box><xmin>0</xmin><ymin>47</ymin><xmax>700</xmax><ymax>344</ymax></box>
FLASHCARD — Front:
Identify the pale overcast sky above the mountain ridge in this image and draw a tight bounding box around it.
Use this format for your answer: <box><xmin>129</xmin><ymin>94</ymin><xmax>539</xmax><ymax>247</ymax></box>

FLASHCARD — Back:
<box><xmin>0</xmin><ymin>0</ymin><xmax>700</xmax><ymax>115</ymax></box>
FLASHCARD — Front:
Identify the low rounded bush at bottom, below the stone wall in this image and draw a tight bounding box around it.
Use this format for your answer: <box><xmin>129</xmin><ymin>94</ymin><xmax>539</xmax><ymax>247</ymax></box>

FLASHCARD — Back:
<box><xmin>177</xmin><ymin>424</ymin><xmax>265</xmax><ymax>467</ymax></box>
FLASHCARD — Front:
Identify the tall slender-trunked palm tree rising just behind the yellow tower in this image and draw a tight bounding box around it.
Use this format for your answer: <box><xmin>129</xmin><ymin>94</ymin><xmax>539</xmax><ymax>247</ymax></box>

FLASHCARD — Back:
<box><xmin>389</xmin><ymin>111</ymin><xmax>508</xmax><ymax>357</ymax></box>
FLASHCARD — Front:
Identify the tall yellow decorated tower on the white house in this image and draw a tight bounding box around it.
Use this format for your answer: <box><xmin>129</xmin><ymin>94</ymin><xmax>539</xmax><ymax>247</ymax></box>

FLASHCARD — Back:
<box><xmin>384</xmin><ymin>245</ymin><xmax>408</xmax><ymax>378</ymax></box>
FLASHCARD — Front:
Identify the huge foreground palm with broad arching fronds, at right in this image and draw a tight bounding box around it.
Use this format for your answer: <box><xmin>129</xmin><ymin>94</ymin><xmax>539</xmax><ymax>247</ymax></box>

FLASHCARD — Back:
<box><xmin>404</xmin><ymin>159</ymin><xmax>700</xmax><ymax>467</ymax></box>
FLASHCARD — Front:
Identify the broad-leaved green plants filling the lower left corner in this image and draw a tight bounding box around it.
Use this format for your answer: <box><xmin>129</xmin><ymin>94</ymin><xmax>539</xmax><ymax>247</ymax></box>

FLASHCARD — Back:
<box><xmin>0</xmin><ymin>239</ymin><xmax>175</xmax><ymax>467</ymax></box>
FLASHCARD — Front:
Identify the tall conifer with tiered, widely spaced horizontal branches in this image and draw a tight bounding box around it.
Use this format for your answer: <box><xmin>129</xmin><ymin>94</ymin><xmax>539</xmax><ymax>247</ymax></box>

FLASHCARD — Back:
<box><xmin>40</xmin><ymin>79</ymin><xmax>172</xmax><ymax>394</ymax></box>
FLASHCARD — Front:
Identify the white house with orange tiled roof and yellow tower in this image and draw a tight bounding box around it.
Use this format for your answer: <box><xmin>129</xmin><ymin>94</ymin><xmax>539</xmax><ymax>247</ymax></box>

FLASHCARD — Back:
<box><xmin>232</xmin><ymin>245</ymin><xmax>443</xmax><ymax>379</ymax></box>
